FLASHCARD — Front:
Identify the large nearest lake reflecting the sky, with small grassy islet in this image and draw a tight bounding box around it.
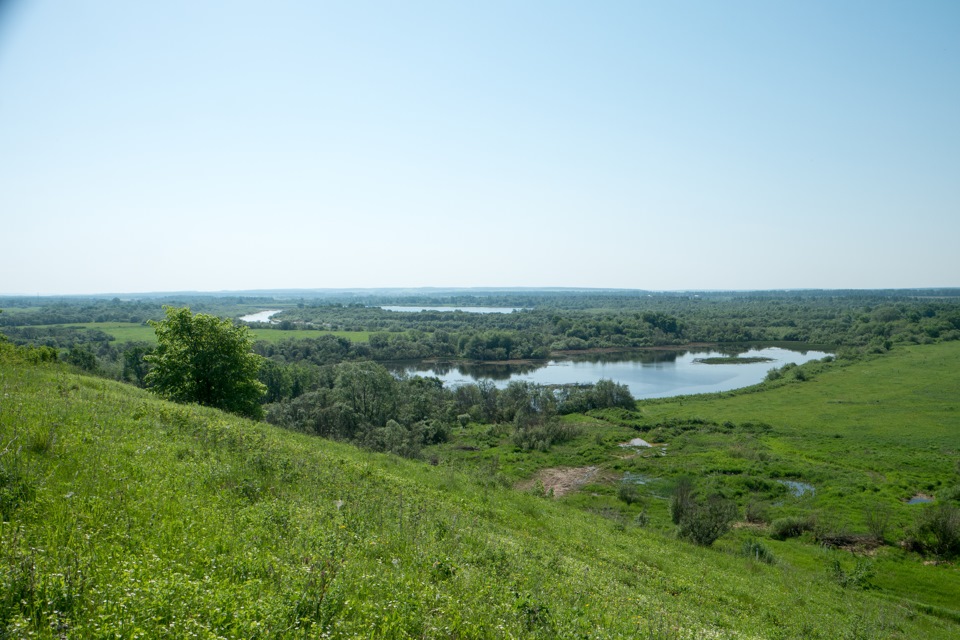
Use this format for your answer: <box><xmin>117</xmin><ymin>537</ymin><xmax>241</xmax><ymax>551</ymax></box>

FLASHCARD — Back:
<box><xmin>393</xmin><ymin>347</ymin><xmax>832</xmax><ymax>399</ymax></box>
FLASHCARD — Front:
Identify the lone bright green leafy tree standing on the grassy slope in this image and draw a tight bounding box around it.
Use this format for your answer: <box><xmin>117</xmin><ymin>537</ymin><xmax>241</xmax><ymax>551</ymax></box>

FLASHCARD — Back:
<box><xmin>144</xmin><ymin>307</ymin><xmax>266</xmax><ymax>418</ymax></box>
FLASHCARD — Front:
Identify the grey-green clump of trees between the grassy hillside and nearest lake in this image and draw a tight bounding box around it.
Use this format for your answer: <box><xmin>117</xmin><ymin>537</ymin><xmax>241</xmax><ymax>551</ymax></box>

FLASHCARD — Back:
<box><xmin>266</xmin><ymin>361</ymin><xmax>636</xmax><ymax>457</ymax></box>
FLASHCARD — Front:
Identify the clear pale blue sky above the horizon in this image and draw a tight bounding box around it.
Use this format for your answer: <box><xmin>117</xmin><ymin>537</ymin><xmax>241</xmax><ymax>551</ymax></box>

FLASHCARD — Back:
<box><xmin>0</xmin><ymin>0</ymin><xmax>960</xmax><ymax>295</ymax></box>
